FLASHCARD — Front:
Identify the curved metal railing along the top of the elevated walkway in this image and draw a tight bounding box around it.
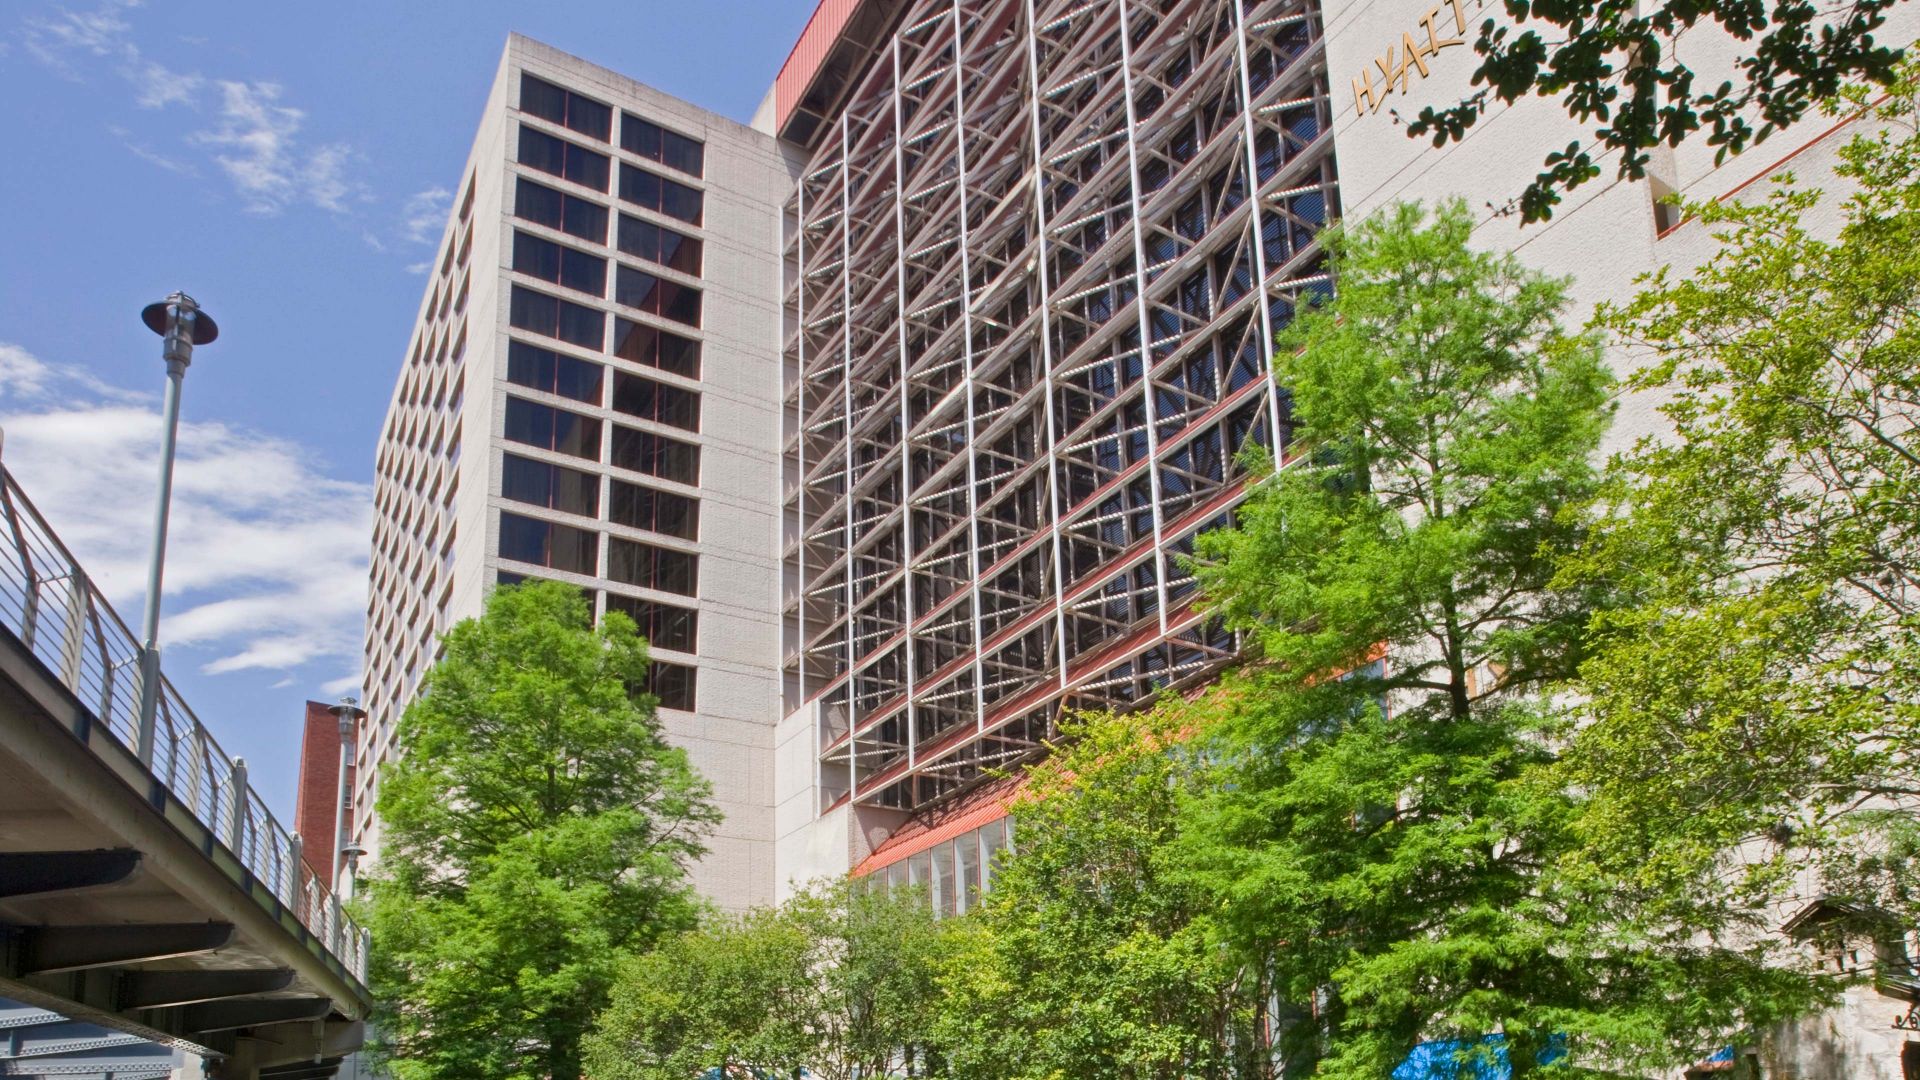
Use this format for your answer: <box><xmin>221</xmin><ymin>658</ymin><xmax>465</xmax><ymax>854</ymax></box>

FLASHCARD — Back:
<box><xmin>0</xmin><ymin>457</ymin><xmax>367</xmax><ymax>984</ymax></box>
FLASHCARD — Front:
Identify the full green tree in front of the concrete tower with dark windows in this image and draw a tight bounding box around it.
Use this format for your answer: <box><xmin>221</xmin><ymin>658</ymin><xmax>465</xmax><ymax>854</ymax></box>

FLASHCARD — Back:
<box><xmin>369</xmin><ymin>582</ymin><xmax>718</xmax><ymax>1080</ymax></box>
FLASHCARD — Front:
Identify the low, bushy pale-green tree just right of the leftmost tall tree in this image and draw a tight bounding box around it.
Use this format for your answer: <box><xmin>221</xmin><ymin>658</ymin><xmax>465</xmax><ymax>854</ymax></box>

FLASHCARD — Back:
<box><xmin>588</xmin><ymin>882</ymin><xmax>947</xmax><ymax>1080</ymax></box>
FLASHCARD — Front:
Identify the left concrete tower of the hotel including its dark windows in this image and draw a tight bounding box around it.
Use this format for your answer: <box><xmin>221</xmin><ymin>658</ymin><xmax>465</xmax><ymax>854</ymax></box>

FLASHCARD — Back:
<box><xmin>353</xmin><ymin>35</ymin><xmax>791</xmax><ymax>907</ymax></box>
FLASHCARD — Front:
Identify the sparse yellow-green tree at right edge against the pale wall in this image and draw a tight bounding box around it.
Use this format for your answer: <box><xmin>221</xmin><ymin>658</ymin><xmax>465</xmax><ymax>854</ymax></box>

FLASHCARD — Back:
<box><xmin>1567</xmin><ymin>65</ymin><xmax>1920</xmax><ymax>932</ymax></box>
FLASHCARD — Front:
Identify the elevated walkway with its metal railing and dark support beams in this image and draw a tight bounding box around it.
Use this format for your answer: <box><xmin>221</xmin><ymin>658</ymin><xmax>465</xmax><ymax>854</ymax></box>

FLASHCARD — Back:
<box><xmin>0</xmin><ymin>455</ymin><xmax>371</xmax><ymax>1080</ymax></box>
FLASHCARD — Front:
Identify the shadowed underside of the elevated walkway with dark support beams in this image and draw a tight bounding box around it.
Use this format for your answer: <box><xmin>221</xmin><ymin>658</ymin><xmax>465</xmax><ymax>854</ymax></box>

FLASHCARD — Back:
<box><xmin>0</xmin><ymin>628</ymin><xmax>365</xmax><ymax>1080</ymax></box>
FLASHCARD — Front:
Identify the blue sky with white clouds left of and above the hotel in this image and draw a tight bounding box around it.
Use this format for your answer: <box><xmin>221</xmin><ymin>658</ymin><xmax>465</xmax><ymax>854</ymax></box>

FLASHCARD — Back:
<box><xmin>0</xmin><ymin>0</ymin><xmax>814</xmax><ymax>813</ymax></box>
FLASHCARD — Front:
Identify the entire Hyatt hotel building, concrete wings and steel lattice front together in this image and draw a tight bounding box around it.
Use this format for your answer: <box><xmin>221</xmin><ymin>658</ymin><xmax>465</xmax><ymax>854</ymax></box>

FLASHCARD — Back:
<box><xmin>357</xmin><ymin>12</ymin><xmax>1920</xmax><ymax>1045</ymax></box>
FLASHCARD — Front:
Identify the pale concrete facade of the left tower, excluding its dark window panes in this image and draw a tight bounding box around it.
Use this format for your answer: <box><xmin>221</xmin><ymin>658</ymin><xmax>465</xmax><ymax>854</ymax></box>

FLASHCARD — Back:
<box><xmin>355</xmin><ymin>35</ymin><xmax>791</xmax><ymax>907</ymax></box>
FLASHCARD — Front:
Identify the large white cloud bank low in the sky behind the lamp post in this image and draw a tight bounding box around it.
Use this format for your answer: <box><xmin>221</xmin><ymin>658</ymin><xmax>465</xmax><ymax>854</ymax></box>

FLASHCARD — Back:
<box><xmin>0</xmin><ymin>342</ymin><xmax>372</xmax><ymax>684</ymax></box>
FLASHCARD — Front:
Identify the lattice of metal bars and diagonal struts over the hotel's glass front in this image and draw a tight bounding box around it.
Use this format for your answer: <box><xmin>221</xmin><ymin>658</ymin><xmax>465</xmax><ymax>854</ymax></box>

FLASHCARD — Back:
<box><xmin>783</xmin><ymin>0</ymin><xmax>1338</xmax><ymax>809</ymax></box>
